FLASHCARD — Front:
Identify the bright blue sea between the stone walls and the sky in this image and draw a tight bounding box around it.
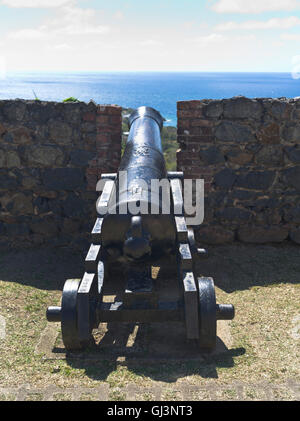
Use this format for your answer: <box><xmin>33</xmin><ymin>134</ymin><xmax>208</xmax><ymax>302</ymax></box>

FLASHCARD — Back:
<box><xmin>0</xmin><ymin>72</ymin><xmax>300</xmax><ymax>126</ymax></box>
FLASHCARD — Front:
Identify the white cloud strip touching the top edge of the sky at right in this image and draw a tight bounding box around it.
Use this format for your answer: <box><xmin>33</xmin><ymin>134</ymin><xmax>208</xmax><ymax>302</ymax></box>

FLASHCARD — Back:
<box><xmin>212</xmin><ymin>0</ymin><xmax>300</xmax><ymax>13</ymax></box>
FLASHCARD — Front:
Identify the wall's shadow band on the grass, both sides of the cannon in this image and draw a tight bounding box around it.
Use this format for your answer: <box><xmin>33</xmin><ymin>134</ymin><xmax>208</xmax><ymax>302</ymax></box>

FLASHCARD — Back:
<box><xmin>0</xmin><ymin>242</ymin><xmax>300</xmax><ymax>293</ymax></box>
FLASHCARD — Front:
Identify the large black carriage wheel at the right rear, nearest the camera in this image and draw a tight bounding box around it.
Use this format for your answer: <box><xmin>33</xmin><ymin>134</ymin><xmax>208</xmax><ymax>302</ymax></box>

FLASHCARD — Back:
<box><xmin>198</xmin><ymin>277</ymin><xmax>217</xmax><ymax>350</ymax></box>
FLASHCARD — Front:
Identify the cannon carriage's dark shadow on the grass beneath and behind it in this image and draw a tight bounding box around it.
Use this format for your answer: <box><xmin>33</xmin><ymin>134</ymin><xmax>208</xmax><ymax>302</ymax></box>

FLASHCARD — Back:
<box><xmin>62</xmin><ymin>324</ymin><xmax>245</xmax><ymax>386</ymax></box>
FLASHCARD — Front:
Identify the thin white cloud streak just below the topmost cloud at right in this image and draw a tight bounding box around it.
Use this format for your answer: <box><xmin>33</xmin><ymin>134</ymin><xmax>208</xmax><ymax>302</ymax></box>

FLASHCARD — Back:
<box><xmin>215</xmin><ymin>16</ymin><xmax>300</xmax><ymax>31</ymax></box>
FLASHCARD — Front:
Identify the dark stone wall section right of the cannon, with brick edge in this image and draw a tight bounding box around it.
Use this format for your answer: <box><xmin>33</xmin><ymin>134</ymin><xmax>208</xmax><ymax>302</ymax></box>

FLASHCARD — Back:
<box><xmin>177</xmin><ymin>97</ymin><xmax>300</xmax><ymax>244</ymax></box>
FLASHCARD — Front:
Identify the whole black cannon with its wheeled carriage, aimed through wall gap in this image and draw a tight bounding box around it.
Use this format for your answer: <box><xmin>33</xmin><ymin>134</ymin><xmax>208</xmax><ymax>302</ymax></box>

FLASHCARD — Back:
<box><xmin>46</xmin><ymin>107</ymin><xmax>234</xmax><ymax>351</ymax></box>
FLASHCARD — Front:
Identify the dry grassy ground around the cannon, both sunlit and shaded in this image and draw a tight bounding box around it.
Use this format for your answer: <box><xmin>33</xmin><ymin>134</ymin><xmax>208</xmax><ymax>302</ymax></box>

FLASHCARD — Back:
<box><xmin>0</xmin><ymin>244</ymin><xmax>300</xmax><ymax>400</ymax></box>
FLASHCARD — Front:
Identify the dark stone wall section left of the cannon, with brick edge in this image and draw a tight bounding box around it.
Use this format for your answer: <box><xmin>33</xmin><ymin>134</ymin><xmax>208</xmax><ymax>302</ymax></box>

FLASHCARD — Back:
<box><xmin>0</xmin><ymin>100</ymin><xmax>122</xmax><ymax>247</ymax></box>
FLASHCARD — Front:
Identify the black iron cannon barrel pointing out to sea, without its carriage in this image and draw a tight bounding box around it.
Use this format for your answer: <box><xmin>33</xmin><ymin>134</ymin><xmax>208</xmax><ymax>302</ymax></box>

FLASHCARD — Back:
<box><xmin>102</xmin><ymin>107</ymin><xmax>176</xmax><ymax>261</ymax></box>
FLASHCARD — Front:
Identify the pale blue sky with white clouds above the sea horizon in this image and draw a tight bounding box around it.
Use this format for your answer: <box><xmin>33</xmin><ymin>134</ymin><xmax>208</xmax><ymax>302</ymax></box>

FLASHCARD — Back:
<box><xmin>0</xmin><ymin>0</ymin><xmax>300</xmax><ymax>74</ymax></box>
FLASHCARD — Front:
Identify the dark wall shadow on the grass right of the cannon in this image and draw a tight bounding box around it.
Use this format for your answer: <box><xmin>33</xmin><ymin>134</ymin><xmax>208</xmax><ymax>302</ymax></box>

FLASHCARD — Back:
<box><xmin>197</xmin><ymin>242</ymin><xmax>300</xmax><ymax>293</ymax></box>
